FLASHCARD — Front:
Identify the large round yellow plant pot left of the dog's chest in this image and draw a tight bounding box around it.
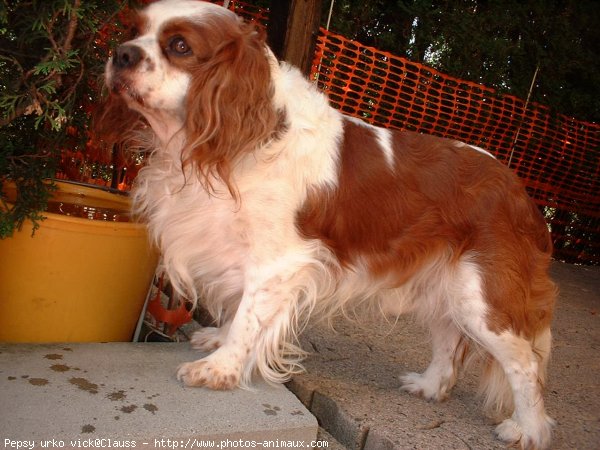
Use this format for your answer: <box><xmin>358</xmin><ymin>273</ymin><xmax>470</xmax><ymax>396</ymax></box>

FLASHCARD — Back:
<box><xmin>0</xmin><ymin>179</ymin><xmax>157</xmax><ymax>342</ymax></box>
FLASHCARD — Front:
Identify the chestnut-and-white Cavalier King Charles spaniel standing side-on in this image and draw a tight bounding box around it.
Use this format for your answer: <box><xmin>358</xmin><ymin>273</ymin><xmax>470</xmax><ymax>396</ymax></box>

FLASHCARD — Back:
<box><xmin>101</xmin><ymin>0</ymin><xmax>556</xmax><ymax>449</ymax></box>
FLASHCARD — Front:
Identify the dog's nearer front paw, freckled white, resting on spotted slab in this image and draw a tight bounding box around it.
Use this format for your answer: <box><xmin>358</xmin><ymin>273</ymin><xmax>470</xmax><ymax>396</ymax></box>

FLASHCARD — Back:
<box><xmin>177</xmin><ymin>353</ymin><xmax>241</xmax><ymax>390</ymax></box>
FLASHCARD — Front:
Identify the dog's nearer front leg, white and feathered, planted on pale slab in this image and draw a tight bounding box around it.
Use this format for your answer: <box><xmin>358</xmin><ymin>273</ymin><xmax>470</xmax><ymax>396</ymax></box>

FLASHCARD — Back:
<box><xmin>177</xmin><ymin>260</ymin><xmax>308</xmax><ymax>389</ymax></box>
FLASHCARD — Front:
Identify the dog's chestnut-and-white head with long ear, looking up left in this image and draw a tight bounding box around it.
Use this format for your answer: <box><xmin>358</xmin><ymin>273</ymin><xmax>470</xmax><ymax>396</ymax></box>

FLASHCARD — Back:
<box><xmin>105</xmin><ymin>0</ymin><xmax>278</xmax><ymax>195</ymax></box>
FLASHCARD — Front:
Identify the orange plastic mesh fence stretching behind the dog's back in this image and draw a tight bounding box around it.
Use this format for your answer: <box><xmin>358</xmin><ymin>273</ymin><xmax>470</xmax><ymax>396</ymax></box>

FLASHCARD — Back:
<box><xmin>312</xmin><ymin>29</ymin><xmax>600</xmax><ymax>264</ymax></box>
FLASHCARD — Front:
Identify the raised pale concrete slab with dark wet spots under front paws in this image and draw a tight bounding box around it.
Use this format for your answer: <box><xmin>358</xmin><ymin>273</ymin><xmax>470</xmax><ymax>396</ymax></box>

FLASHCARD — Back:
<box><xmin>0</xmin><ymin>343</ymin><xmax>318</xmax><ymax>448</ymax></box>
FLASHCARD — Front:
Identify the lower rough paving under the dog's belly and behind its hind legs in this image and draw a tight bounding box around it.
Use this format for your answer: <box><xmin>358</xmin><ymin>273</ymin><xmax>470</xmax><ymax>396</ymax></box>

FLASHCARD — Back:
<box><xmin>288</xmin><ymin>262</ymin><xmax>600</xmax><ymax>450</ymax></box>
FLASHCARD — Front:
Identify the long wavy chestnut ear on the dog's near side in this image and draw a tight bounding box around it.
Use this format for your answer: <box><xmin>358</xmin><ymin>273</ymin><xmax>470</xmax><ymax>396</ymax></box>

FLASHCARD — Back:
<box><xmin>185</xmin><ymin>21</ymin><xmax>279</xmax><ymax>197</ymax></box>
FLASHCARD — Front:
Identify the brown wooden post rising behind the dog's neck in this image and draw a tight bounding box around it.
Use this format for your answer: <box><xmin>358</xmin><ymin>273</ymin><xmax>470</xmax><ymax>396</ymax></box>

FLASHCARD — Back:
<box><xmin>267</xmin><ymin>0</ymin><xmax>321</xmax><ymax>75</ymax></box>
